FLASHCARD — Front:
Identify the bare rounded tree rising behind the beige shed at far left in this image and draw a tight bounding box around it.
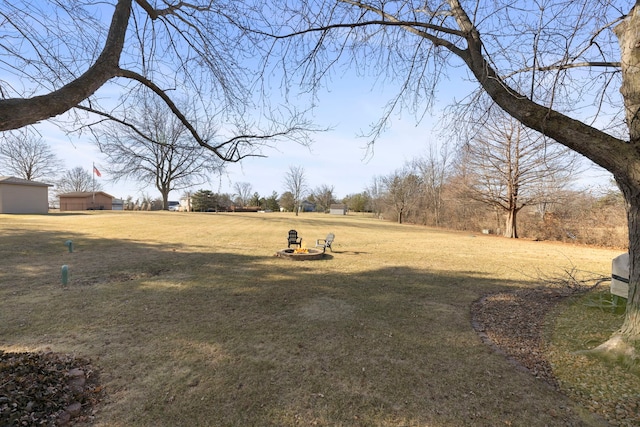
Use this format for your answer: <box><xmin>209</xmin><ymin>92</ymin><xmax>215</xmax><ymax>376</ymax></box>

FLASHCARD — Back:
<box><xmin>0</xmin><ymin>129</ymin><xmax>63</xmax><ymax>181</ymax></box>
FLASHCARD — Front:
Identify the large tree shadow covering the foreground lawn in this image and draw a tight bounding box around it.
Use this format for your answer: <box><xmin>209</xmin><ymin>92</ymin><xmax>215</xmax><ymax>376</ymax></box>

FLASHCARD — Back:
<box><xmin>0</xmin><ymin>230</ymin><xmax>592</xmax><ymax>426</ymax></box>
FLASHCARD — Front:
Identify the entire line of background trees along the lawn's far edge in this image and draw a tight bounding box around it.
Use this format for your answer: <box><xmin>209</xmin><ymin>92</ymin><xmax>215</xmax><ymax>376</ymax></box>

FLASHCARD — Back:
<box><xmin>0</xmin><ymin>119</ymin><xmax>628</xmax><ymax>247</ymax></box>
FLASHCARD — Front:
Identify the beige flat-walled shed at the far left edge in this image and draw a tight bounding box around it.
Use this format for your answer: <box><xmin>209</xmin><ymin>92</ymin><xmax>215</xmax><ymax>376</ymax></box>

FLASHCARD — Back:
<box><xmin>0</xmin><ymin>176</ymin><xmax>53</xmax><ymax>214</ymax></box>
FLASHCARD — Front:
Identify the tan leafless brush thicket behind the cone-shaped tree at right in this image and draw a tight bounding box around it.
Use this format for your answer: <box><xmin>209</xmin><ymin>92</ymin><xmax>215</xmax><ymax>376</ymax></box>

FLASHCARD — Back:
<box><xmin>364</xmin><ymin>164</ymin><xmax>628</xmax><ymax>248</ymax></box>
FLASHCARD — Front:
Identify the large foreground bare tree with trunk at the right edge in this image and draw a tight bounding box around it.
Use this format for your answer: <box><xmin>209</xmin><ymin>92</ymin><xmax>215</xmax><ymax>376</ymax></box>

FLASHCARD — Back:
<box><xmin>258</xmin><ymin>0</ymin><xmax>640</xmax><ymax>353</ymax></box>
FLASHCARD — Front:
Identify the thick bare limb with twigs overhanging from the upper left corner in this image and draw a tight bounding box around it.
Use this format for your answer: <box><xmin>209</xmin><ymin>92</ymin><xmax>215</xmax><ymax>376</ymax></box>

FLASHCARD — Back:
<box><xmin>0</xmin><ymin>0</ymin><xmax>311</xmax><ymax>162</ymax></box>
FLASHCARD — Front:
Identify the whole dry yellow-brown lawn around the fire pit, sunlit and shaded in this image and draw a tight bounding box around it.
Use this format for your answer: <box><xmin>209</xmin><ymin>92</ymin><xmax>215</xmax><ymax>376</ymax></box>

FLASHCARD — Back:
<box><xmin>0</xmin><ymin>212</ymin><xmax>621</xmax><ymax>426</ymax></box>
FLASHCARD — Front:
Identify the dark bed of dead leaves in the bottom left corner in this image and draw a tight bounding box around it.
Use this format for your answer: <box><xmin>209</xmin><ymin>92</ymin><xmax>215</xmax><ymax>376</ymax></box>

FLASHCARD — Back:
<box><xmin>0</xmin><ymin>351</ymin><xmax>102</xmax><ymax>426</ymax></box>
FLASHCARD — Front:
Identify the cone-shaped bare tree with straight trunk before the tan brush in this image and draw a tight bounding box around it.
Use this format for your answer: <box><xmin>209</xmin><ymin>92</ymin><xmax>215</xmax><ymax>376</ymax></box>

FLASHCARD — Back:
<box><xmin>459</xmin><ymin>114</ymin><xmax>578</xmax><ymax>238</ymax></box>
